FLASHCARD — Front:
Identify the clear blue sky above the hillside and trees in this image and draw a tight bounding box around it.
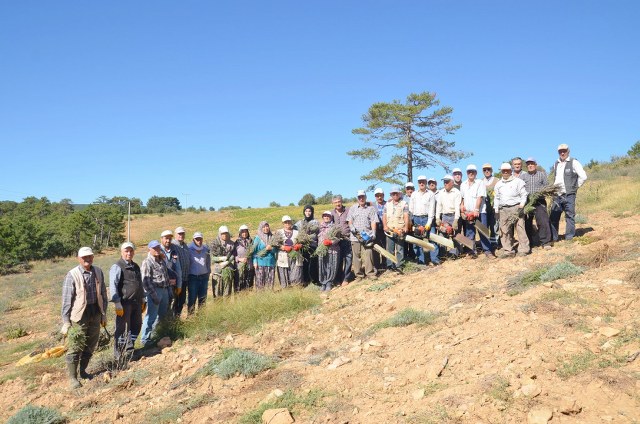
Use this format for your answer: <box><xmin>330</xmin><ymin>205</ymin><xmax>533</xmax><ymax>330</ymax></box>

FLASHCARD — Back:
<box><xmin>0</xmin><ymin>0</ymin><xmax>640</xmax><ymax>208</ymax></box>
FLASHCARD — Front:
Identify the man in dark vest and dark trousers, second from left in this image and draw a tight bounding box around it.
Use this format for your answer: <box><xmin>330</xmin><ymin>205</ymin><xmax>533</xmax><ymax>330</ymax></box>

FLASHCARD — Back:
<box><xmin>109</xmin><ymin>242</ymin><xmax>144</xmax><ymax>361</ymax></box>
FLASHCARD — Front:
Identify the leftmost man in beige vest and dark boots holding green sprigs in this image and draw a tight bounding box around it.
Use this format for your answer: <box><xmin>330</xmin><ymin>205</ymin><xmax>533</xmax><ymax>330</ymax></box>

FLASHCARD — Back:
<box><xmin>60</xmin><ymin>247</ymin><xmax>108</xmax><ymax>389</ymax></box>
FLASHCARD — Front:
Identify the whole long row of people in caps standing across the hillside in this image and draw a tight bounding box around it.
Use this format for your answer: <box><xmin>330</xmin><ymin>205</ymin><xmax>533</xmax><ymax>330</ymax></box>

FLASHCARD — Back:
<box><xmin>61</xmin><ymin>144</ymin><xmax>587</xmax><ymax>388</ymax></box>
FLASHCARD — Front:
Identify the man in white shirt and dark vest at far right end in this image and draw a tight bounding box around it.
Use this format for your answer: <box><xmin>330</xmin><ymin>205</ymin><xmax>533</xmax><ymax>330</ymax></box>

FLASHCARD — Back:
<box><xmin>550</xmin><ymin>144</ymin><xmax>587</xmax><ymax>241</ymax></box>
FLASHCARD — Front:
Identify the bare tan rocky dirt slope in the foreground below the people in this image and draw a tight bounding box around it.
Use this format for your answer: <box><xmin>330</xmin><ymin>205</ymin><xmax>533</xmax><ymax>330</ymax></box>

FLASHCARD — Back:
<box><xmin>0</xmin><ymin>214</ymin><xmax>640</xmax><ymax>423</ymax></box>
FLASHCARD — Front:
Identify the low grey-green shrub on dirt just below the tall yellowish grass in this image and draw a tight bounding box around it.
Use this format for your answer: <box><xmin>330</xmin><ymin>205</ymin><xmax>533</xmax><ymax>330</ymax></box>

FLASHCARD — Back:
<box><xmin>202</xmin><ymin>349</ymin><xmax>275</xmax><ymax>380</ymax></box>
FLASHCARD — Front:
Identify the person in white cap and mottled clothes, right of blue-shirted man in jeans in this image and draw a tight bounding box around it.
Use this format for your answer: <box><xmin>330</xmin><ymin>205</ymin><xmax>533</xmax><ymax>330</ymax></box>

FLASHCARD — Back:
<box><xmin>210</xmin><ymin>225</ymin><xmax>236</xmax><ymax>297</ymax></box>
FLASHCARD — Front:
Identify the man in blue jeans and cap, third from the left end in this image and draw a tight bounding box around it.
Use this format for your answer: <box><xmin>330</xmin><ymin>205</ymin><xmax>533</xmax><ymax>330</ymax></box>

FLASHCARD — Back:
<box><xmin>140</xmin><ymin>240</ymin><xmax>175</xmax><ymax>346</ymax></box>
